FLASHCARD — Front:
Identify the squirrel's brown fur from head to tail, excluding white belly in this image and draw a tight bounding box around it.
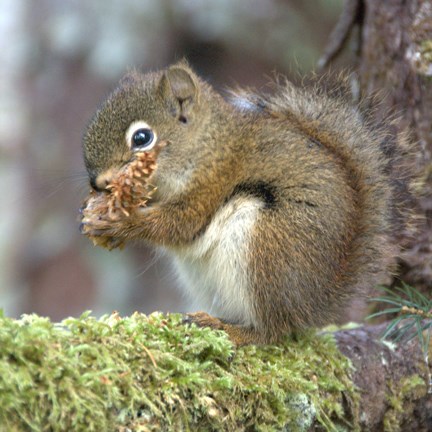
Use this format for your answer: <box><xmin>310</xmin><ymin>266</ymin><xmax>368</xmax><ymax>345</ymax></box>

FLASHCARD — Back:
<box><xmin>80</xmin><ymin>62</ymin><xmax>411</xmax><ymax>344</ymax></box>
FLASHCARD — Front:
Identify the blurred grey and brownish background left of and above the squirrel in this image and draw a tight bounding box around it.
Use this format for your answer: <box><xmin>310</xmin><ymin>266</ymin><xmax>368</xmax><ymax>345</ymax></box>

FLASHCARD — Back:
<box><xmin>0</xmin><ymin>0</ymin><xmax>342</xmax><ymax>320</ymax></box>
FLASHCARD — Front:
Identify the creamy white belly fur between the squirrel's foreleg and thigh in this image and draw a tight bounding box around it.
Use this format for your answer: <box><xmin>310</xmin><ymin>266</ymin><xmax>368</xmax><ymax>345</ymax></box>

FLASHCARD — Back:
<box><xmin>172</xmin><ymin>197</ymin><xmax>263</xmax><ymax>326</ymax></box>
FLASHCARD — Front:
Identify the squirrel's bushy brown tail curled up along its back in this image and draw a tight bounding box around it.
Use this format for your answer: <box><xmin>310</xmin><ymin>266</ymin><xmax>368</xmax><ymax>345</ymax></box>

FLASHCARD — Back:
<box><xmin>240</xmin><ymin>73</ymin><xmax>416</xmax><ymax>296</ymax></box>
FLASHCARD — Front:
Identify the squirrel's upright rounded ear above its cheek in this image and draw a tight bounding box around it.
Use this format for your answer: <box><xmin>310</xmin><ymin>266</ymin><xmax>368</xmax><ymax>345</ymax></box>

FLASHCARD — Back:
<box><xmin>159</xmin><ymin>62</ymin><xmax>199</xmax><ymax>123</ymax></box>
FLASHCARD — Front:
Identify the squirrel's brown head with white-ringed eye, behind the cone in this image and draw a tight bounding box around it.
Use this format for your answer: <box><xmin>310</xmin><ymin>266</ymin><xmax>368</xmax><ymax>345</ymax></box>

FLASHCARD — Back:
<box><xmin>83</xmin><ymin>61</ymin><xmax>222</xmax><ymax>199</ymax></box>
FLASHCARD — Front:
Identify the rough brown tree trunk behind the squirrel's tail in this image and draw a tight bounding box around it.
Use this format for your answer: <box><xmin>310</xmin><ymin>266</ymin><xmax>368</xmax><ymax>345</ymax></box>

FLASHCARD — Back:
<box><xmin>321</xmin><ymin>0</ymin><xmax>432</xmax><ymax>293</ymax></box>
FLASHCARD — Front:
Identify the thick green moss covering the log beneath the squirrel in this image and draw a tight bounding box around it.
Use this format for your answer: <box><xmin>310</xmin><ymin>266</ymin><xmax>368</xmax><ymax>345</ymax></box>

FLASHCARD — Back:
<box><xmin>0</xmin><ymin>313</ymin><xmax>358</xmax><ymax>431</ymax></box>
